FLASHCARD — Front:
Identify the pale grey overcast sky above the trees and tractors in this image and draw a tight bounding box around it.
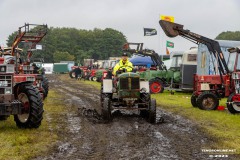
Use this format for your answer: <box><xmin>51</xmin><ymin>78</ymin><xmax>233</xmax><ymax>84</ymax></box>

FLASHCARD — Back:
<box><xmin>0</xmin><ymin>0</ymin><xmax>240</xmax><ymax>54</ymax></box>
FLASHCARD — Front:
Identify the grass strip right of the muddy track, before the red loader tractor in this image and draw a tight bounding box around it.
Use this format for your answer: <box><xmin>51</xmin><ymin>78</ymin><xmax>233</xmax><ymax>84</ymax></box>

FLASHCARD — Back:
<box><xmin>152</xmin><ymin>91</ymin><xmax>240</xmax><ymax>153</ymax></box>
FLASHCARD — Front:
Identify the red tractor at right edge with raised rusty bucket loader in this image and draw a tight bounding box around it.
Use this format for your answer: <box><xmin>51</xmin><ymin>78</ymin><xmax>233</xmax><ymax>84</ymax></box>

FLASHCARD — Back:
<box><xmin>159</xmin><ymin>20</ymin><xmax>240</xmax><ymax>113</ymax></box>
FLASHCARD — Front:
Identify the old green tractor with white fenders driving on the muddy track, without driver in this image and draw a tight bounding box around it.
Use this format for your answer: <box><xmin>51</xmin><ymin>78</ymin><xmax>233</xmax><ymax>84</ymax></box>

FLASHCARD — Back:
<box><xmin>100</xmin><ymin>68</ymin><xmax>156</xmax><ymax>123</ymax></box>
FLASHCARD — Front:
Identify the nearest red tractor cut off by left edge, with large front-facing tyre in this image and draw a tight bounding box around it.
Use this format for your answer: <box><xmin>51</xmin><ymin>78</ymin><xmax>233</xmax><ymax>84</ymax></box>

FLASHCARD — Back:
<box><xmin>0</xmin><ymin>57</ymin><xmax>43</xmax><ymax>128</ymax></box>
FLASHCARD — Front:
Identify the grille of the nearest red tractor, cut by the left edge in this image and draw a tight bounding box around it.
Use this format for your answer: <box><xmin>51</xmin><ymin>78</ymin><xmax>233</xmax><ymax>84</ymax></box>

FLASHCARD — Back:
<box><xmin>0</xmin><ymin>75</ymin><xmax>12</xmax><ymax>94</ymax></box>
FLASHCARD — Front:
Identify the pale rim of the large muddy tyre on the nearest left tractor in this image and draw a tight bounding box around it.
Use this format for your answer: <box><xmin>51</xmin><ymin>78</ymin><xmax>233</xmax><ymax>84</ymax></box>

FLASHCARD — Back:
<box><xmin>17</xmin><ymin>93</ymin><xmax>30</xmax><ymax>123</ymax></box>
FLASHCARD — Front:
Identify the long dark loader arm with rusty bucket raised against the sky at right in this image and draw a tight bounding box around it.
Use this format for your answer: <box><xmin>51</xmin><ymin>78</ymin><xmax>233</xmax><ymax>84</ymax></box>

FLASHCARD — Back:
<box><xmin>159</xmin><ymin>20</ymin><xmax>230</xmax><ymax>74</ymax></box>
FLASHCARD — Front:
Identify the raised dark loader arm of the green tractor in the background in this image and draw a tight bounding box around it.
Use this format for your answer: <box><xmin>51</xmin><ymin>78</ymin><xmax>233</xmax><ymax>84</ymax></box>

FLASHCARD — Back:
<box><xmin>123</xmin><ymin>43</ymin><xmax>164</xmax><ymax>70</ymax></box>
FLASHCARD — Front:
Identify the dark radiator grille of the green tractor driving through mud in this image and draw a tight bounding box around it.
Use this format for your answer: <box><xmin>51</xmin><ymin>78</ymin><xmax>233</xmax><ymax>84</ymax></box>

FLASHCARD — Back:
<box><xmin>120</xmin><ymin>78</ymin><xmax>140</xmax><ymax>90</ymax></box>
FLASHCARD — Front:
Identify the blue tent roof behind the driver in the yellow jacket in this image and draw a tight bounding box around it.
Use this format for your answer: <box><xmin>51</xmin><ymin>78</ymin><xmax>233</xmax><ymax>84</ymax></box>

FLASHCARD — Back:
<box><xmin>129</xmin><ymin>56</ymin><xmax>154</xmax><ymax>66</ymax></box>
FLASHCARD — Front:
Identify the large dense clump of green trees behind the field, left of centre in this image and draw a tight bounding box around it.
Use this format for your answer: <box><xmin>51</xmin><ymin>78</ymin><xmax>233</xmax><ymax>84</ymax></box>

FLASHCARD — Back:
<box><xmin>7</xmin><ymin>27</ymin><xmax>127</xmax><ymax>63</ymax></box>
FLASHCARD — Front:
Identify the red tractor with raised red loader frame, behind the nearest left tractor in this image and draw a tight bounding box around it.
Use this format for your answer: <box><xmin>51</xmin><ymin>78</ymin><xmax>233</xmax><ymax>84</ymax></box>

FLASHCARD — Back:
<box><xmin>8</xmin><ymin>24</ymin><xmax>48</xmax><ymax>99</ymax></box>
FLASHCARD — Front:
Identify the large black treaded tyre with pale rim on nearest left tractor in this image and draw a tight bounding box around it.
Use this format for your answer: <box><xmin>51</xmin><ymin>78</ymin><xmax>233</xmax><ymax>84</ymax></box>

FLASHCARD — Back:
<box><xmin>14</xmin><ymin>84</ymin><xmax>43</xmax><ymax>128</ymax></box>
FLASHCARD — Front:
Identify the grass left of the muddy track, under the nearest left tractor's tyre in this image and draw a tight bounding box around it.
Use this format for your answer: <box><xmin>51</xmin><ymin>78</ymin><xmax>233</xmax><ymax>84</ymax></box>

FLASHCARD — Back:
<box><xmin>0</xmin><ymin>91</ymin><xmax>64</xmax><ymax>160</ymax></box>
